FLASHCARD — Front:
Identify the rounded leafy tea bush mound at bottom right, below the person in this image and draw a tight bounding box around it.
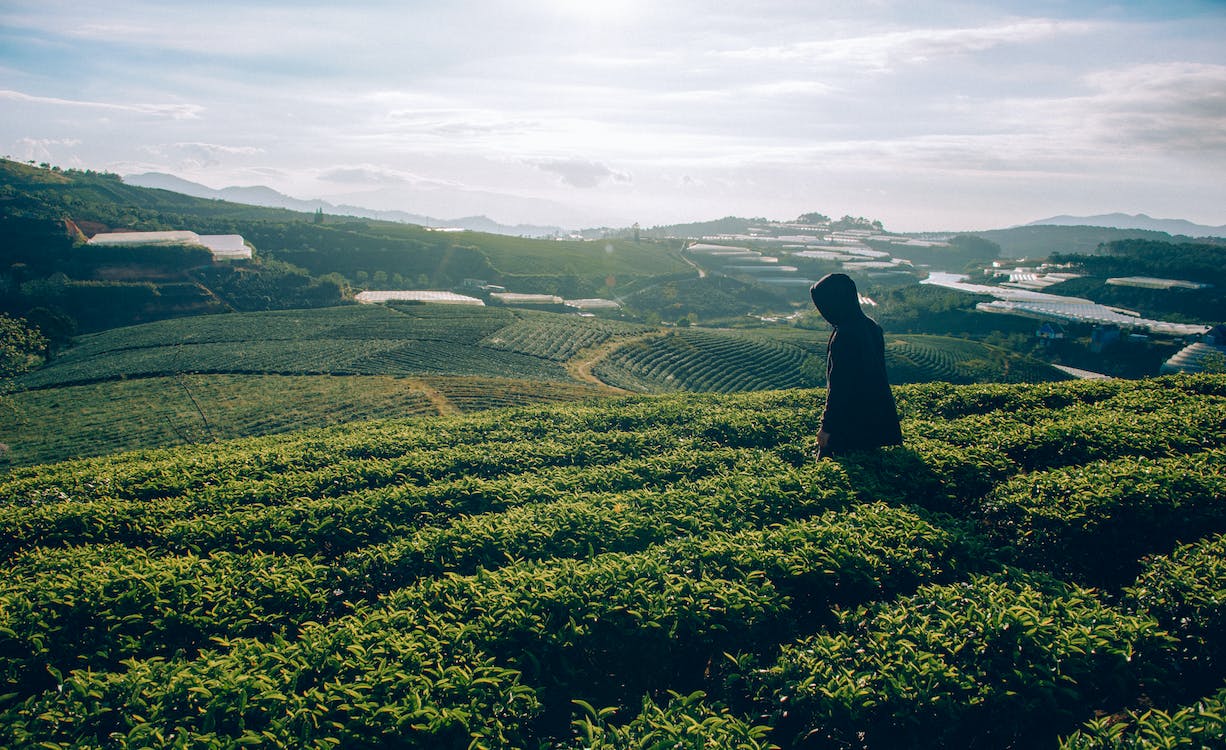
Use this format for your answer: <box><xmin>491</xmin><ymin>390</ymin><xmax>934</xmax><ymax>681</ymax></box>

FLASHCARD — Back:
<box><xmin>754</xmin><ymin>574</ymin><xmax>1167</xmax><ymax>748</ymax></box>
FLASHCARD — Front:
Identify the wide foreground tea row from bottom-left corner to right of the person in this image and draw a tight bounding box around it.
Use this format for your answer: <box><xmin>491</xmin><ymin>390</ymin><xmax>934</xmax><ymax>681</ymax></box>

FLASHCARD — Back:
<box><xmin>0</xmin><ymin>506</ymin><xmax>975</xmax><ymax>748</ymax></box>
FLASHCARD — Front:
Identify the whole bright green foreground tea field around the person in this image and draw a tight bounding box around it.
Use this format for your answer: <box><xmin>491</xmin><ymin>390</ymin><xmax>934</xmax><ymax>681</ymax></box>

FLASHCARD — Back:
<box><xmin>0</xmin><ymin>376</ymin><xmax>1226</xmax><ymax>750</ymax></box>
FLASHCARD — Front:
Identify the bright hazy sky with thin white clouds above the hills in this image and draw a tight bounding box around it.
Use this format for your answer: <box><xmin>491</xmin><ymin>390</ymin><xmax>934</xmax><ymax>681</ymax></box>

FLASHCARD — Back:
<box><xmin>0</xmin><ymin>0</ymin><xmax>1226</xmax><ymax>232</ymax></box>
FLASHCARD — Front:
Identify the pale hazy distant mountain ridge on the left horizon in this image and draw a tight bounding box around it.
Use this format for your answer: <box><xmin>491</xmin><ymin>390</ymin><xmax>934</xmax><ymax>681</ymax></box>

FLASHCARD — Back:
<box><xmin>124</xmin><ymin>172</ymin><xmax>564</xmax><ymax>237</ymax></box>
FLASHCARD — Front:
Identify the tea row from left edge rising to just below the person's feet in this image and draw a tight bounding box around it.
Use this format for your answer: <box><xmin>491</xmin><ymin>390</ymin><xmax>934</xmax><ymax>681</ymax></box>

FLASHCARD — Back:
<box><xmin>0</xmin><ymin>450</ymin><xmax>851</xmax><ymax>700</ymax></box>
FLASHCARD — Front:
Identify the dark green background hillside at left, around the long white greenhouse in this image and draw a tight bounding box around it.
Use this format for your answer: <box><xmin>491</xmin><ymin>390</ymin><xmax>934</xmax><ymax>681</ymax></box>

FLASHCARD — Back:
<box><xmin>0</xmin><ymin>159</ymin><xmax>693</xmax><ymax>332</ymax></box>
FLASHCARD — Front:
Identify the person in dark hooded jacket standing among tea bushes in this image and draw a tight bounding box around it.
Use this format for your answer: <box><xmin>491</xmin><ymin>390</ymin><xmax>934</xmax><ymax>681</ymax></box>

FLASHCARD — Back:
<box><xmin>809</xmin><ymin>273</ymin><xmax>902</xmax><ymax>457</ymax></box>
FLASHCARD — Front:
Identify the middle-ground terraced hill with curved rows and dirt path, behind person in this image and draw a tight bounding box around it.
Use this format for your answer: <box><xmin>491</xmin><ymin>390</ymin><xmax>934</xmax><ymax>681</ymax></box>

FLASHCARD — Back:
<box><xmin>0</xmin><ymin>305</ymin><xmax>1065</xmax><ymax>464</ymax></box>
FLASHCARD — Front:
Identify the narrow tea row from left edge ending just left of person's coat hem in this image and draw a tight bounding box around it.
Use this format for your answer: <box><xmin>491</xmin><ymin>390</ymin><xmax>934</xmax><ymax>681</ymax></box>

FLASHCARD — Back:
<box><xmin>0</xmin><ymin>442</ymin><xmax>760</xmax><ymax>555</ymax></box>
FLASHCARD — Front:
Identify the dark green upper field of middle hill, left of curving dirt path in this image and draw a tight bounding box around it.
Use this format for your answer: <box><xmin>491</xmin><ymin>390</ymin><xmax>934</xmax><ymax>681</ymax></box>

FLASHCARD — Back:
<box><xmin>20</xmin><ymin>305</ymin><xmax>595</xmax><ymax>388</ymax></box>
